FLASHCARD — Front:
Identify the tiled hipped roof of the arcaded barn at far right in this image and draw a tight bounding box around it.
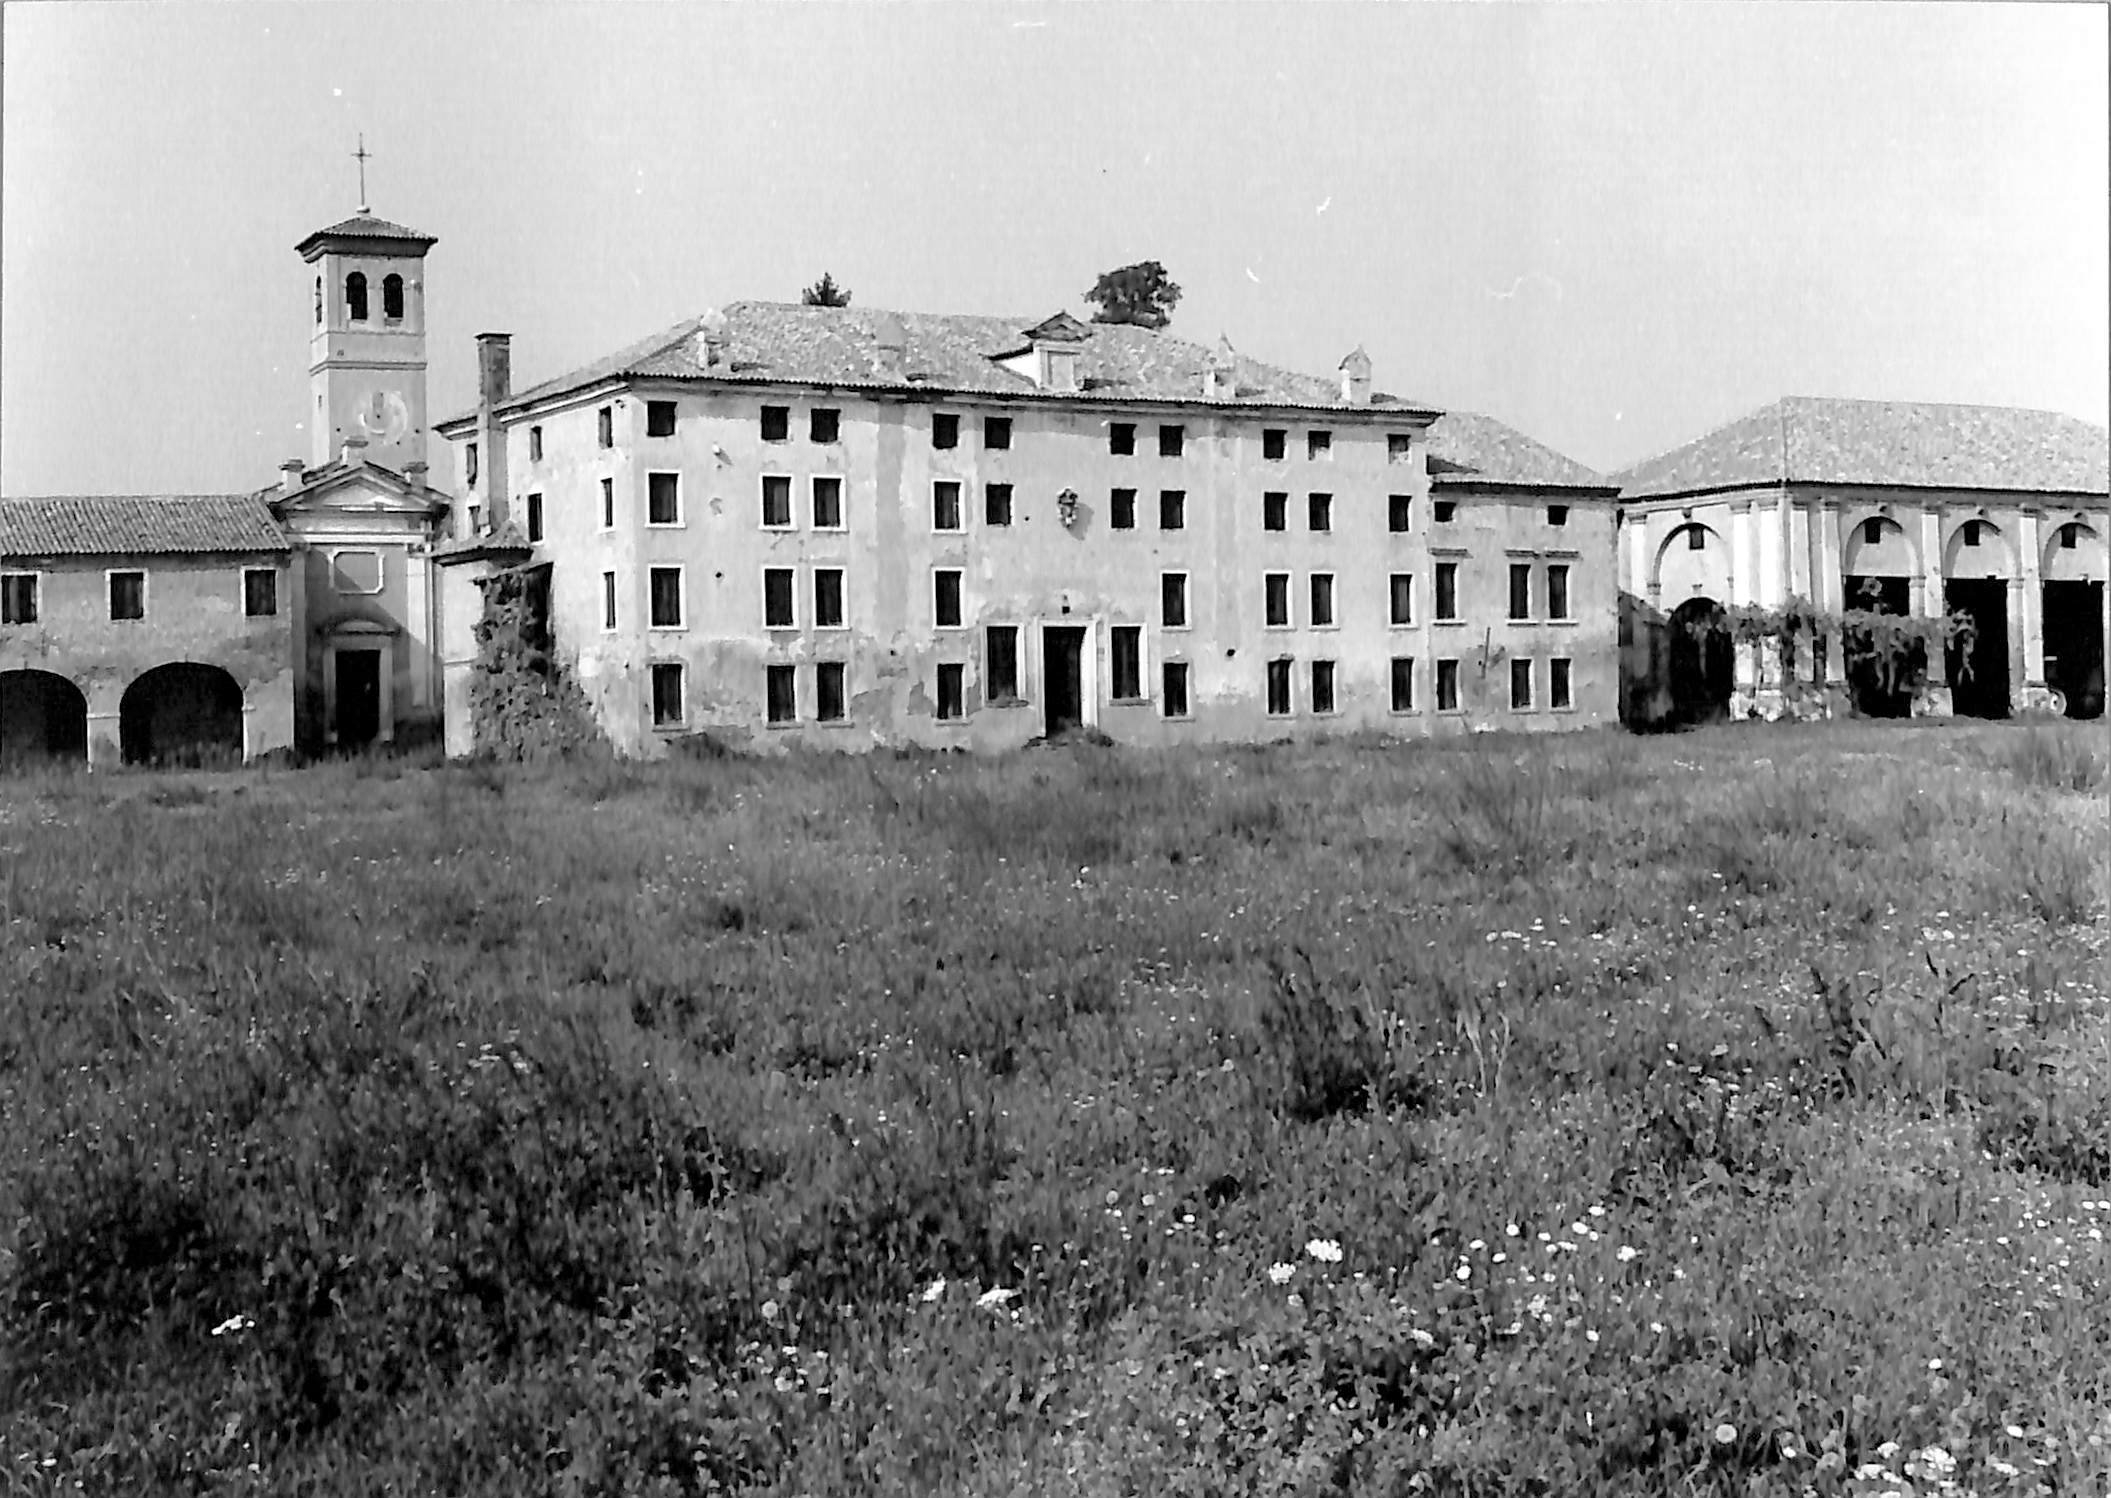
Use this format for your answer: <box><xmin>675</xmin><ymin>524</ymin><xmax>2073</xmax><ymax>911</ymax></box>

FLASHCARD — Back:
<box><xmin>1613</xmin><ymin>397</ymin><xmax>2111</xmax><ymax>500</ymax></box>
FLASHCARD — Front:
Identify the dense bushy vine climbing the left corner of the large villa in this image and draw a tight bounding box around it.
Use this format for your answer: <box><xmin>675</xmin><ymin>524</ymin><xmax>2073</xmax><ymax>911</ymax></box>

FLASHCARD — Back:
<box><xmin>469</xmin><ymin>568</ymin><xmax>608</xmax><ymax>762</ymax></box>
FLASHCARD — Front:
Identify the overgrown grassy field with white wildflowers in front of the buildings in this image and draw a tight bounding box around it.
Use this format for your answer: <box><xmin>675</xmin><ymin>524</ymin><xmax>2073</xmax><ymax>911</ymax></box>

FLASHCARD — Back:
<box><xmin>0</xmin><ymin>726</ymin><xmax>2111</xmax><ymax>1498</ymax></box>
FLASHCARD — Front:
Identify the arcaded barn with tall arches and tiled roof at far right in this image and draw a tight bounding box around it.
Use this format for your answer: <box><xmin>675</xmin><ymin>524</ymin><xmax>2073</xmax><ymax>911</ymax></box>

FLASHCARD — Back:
<box><xmin>1613</xmin><ymin>397</ymin><xmax>2111</xmax><ymax>719</ymax></box>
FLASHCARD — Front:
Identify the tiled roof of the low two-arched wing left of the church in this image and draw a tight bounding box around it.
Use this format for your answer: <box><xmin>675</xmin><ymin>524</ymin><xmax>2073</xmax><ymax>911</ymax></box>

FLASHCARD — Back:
<box><xmin>0</xmin><ymin>494</ymin><xmax>291</xmax><ymax>557</ymax></box>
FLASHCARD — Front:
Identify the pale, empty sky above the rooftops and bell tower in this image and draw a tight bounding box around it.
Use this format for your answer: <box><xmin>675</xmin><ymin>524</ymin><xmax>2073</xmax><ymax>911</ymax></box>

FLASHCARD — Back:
<box><xmin>0</xmin><ymin>0</ymin><xmax>2111</xmax><ymax>494</ymax></box>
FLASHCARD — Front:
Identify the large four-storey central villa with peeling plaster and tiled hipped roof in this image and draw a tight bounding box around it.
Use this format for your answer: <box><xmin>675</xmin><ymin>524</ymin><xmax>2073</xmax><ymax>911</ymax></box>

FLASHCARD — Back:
<box><xmin>437</xmin><ymin>302</ymin><xmax>1619</xmax><ymax>753</ymax></box>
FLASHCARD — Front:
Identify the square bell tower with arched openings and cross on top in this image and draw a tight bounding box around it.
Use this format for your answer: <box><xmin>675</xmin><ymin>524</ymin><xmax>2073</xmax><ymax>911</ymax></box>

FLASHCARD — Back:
<box><xmin>293</xmin><ymin>182</ymin><xmax>439</xmax><ymax>473</ymax></box>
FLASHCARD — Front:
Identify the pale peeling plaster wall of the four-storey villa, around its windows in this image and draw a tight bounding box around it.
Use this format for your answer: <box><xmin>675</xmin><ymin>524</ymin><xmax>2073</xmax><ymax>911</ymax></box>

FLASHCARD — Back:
<box><xmin>450</xmin><ymin>386</ymin><xmax>1617</xmax><ymax>753</ymax></box>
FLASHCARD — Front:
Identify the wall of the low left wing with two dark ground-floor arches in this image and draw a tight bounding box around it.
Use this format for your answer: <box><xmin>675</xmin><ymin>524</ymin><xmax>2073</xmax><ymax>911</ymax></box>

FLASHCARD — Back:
<box><xmin>0</xmin><ymin>553</ymin><xmax>296</xmax><ymax>764</ymax></box>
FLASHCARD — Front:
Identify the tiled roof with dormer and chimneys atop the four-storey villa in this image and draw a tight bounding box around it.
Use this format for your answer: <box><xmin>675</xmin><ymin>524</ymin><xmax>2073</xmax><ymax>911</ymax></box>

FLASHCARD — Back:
<box><xmin>472</xmin><ymin>302</ymin><xmax>1431</xmax><ymax>420</ymax></box>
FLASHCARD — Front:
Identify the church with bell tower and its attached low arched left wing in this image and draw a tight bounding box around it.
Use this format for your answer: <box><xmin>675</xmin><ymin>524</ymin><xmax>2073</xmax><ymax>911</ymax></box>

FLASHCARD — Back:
<box><xmin>0</xmin><ymin>209</ymin><xmax>448</xmax><ymax>764</ymax></box>
